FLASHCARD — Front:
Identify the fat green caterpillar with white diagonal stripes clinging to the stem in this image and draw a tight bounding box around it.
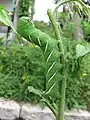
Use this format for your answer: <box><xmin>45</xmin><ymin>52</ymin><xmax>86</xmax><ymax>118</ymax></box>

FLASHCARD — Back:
<box><xmin>17</xmin><ymin>17</ymin><xmax>60</xmax><ymax>97</ymax></box>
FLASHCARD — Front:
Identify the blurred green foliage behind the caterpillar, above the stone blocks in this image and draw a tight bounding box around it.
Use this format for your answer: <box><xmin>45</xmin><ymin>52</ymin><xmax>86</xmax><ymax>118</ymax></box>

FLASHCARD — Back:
<box><xmin>0</xmin><ymin>35</ymin><xmax>90</xmax><ymax>109</ymax></box>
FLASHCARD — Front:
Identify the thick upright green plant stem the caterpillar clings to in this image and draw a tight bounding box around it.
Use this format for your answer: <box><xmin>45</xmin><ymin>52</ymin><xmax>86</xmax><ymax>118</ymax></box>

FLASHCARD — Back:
<box><xmin>47</xmin><ymin>9</ymin><xmax>67</xmax><ymax>120</ymax></box>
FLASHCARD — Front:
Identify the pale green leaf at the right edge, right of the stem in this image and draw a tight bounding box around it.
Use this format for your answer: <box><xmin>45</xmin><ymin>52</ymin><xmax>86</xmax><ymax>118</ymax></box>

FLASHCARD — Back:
<box><xmin>76</xmin><ymin>44</ymin><xmax>90</xmax><ymax>58</ymax></box>
